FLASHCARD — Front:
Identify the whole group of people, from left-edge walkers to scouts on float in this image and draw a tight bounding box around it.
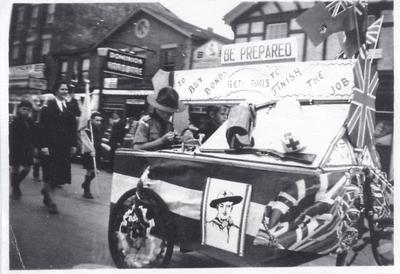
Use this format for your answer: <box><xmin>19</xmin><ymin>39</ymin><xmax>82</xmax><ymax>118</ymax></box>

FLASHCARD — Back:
<box><xmin>9</xmin><ymin>81</ymin><xmax>229</xmax><ymax>214</ymax></box>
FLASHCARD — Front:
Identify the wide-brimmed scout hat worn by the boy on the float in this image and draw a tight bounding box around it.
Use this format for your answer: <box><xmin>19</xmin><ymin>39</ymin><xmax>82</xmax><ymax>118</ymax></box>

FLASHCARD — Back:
<box><xmin>147</xmin><ymin>87</ymin><xmax>185</xmax><ymax>112</ymax></box>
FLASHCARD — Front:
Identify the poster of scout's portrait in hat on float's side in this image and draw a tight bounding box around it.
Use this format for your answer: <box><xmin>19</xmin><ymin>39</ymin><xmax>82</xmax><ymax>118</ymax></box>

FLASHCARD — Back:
<box><xmin>201</xmin><ymin>178</ymin><xmax>251</xmax><ymax>256</ymax></box>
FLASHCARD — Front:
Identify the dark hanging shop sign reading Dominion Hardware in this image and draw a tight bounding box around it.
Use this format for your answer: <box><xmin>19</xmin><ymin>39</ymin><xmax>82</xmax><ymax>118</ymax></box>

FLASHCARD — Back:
<box><xmin>104</xmin><ymin>49</ymin><xmax>145</xmax><ymax>79</ymax></box>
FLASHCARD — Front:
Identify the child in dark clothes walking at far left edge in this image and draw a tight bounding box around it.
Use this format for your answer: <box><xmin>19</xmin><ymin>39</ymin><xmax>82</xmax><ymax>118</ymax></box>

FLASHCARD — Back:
<box><xmin>9</xmin><ymin>100</ymin><xmax>33</xmax><ymax>200</ymax></box>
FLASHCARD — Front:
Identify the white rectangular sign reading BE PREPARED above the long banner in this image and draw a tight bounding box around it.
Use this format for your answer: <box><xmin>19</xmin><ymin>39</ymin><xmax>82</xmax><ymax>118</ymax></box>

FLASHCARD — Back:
<box><xmin>221</xmin><ymin>37</ymin><xmax>297</xmax><ymax>65</ymax></box>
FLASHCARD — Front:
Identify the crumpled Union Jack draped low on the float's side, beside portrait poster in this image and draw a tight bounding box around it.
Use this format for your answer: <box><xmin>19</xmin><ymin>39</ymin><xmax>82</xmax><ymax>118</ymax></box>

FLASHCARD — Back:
<box><xmin>253</xmin><ymin>173</ymin><xmax>347</xmax><ymax>253</ymax></box>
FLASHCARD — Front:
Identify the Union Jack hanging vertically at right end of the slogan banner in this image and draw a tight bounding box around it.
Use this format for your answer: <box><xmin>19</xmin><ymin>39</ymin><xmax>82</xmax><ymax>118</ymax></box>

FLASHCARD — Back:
<box><xmin>346</xmin><ymin>53</ymin><xmax>378</xmax><ymax>148</ymax></box>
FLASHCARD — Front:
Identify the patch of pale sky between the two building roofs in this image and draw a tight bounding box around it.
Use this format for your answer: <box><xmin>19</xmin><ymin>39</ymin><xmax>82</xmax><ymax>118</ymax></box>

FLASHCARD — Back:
<box><xmin>159</xmin><ymin>0</ymin><xmax>243</xmax><ymax>39</ymax></box>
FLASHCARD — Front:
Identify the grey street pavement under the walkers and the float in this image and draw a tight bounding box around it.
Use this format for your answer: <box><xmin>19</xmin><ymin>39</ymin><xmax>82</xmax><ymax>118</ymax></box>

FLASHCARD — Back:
<box><xmin>9</xmin><ymin>164</ymin><xmax>376</xmax><ymax>270</ymax></box>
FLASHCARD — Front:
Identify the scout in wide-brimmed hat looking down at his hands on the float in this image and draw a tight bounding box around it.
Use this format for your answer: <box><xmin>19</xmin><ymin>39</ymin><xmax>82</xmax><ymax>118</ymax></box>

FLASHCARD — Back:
<box><xmin>133</xmin><ymin>87</ymin><xmax>185</xmax><ymax>150</ymax></box>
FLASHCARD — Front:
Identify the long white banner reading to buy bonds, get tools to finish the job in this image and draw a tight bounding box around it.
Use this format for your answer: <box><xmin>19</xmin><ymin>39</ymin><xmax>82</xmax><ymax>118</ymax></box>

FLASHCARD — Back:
<box><xmin>174</xmin><ymin>60</ymin><xmax>355</xmax><ymax>103</ymax></box>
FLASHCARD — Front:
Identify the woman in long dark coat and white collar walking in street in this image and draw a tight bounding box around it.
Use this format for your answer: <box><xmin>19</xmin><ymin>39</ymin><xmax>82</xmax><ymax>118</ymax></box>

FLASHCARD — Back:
<box><xmin>40</xmin><ymin>82</ymin><xmax>77</xmax><ymax>213</ymax></box>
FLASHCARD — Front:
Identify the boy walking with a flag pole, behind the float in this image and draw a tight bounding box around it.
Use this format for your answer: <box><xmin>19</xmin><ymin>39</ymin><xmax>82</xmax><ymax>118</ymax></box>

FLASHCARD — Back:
<box><xmin>82</xmin><ymin>111</ymin><xmax>103</xmax><ymax>199</ymax></box>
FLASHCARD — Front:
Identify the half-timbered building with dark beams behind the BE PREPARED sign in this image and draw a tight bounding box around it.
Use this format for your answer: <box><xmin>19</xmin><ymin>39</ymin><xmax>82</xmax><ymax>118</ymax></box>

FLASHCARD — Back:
<box><xmin>224</xmin><ymin>0</ymin><xmax>394</xmax><ymax>176</ymax></box>
